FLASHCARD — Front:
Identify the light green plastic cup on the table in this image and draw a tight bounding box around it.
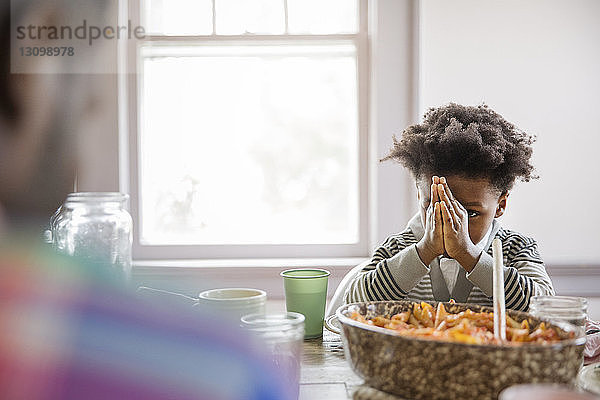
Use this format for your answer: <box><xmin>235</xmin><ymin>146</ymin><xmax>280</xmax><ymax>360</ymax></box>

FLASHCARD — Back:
<box><xmin>281</xmin><ymin>268</ymin><xmax>329</xmax><ymax>339</ymax></box>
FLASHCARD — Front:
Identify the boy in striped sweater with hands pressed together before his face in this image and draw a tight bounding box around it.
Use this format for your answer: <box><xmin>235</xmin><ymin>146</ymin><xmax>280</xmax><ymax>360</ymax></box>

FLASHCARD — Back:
<box><xmin>345</xmin><ymin>104</ymin><xmax>554</xmax><ymax>311</ymax></box>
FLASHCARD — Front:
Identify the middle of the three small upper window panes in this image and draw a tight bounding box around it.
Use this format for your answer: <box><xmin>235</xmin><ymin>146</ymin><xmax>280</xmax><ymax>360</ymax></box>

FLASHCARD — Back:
<box><xmin>215</xmin><ymin>0</ymin><xmax>285</xmax><ymax>35</ymax></box>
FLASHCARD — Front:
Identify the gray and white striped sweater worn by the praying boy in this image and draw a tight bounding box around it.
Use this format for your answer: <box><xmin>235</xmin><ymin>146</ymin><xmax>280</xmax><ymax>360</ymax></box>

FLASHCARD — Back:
<box><xmin>345</xmin><ymin>214</ymin><xmax>554</xmax><ymax>311</ymax></box>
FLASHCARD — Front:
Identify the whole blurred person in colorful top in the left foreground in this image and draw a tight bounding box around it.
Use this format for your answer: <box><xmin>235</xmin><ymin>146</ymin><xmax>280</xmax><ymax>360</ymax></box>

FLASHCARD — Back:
<box><xmin>0</xmin><ymin>0</ymin><xmax>297</xmax><ymax>400</ymax></box>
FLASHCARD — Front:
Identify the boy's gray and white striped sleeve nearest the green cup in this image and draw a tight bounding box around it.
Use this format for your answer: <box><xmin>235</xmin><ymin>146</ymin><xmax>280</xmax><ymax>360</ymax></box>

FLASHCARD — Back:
<box><xmin>344</xmin><ymin>237</ymin><xmax>429</xmax><ymax>303</ymax></box>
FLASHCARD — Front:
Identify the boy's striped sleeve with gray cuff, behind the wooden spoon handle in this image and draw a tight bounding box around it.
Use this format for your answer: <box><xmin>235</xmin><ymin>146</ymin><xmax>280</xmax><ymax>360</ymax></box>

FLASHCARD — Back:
<box><xmin>467</xmin><ymin>237</ymin><xmax>554</xmax><ymax>311</ymax></box>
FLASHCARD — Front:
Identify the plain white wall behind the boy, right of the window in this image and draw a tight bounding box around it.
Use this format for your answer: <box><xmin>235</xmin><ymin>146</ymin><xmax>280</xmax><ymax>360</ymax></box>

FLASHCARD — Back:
<box><xmin>419</xmin><ymin>0</ymin><xmax>600</xmax><ymax>265</ymax></box>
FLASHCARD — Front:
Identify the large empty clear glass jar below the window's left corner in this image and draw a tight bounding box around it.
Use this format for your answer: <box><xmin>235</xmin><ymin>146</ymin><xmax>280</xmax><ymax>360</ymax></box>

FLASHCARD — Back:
<box><xmin>50</xmin><ymin>192</ymin><xmax>133</xmax><ymax>279</ymax></box>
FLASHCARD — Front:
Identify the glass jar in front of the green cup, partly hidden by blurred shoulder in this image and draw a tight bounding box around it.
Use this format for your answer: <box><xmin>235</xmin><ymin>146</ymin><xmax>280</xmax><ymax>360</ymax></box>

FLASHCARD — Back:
<box><xmin>241</xmin><ymin>312</ymin><xmax>304</xmax><ymax>398</ymax></box>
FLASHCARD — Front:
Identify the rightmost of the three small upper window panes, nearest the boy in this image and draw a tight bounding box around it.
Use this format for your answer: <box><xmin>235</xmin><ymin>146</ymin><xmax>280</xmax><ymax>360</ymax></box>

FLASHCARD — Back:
<box><xmin>288</xmin><ymin>0</ymin><xmax>358</xmax><ymax>34</ymax></box>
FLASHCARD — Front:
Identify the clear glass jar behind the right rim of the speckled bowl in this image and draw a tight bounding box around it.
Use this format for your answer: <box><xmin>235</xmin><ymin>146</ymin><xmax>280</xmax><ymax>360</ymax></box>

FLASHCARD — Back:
<box><xmin>529</xmin><ymin>296</ymin><xmax>587</xmax><ymax>327</ymax></box>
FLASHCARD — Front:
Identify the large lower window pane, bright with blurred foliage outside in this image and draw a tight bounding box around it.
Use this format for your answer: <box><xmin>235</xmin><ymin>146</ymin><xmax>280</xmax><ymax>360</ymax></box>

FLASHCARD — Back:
<box><xmin>140</xmin><ymin>44</ymin><xmax>359</xmax><ymax>244</ymax></box>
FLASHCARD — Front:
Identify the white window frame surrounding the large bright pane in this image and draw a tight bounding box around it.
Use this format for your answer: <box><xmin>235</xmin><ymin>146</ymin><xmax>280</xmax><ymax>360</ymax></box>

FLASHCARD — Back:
<box><xmin>119</xmin><ymin>0</ymin><xmax>372</xmax><ymax>260</ymax></box>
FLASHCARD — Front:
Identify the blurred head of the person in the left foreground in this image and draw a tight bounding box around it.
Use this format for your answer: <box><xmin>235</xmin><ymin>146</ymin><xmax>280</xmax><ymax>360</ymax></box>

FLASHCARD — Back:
<box><xmin>0</xmin><ymin>0</ymin><xmax>78</xmax><ymax>229</ymax></box>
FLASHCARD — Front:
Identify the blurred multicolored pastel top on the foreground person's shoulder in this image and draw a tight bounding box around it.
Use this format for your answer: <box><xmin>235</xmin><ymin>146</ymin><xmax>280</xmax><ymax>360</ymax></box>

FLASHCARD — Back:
<box><xmin>0</xmin><ymin>244</ymin><xmax>297</xmax><ymax>400</ymax></box>
